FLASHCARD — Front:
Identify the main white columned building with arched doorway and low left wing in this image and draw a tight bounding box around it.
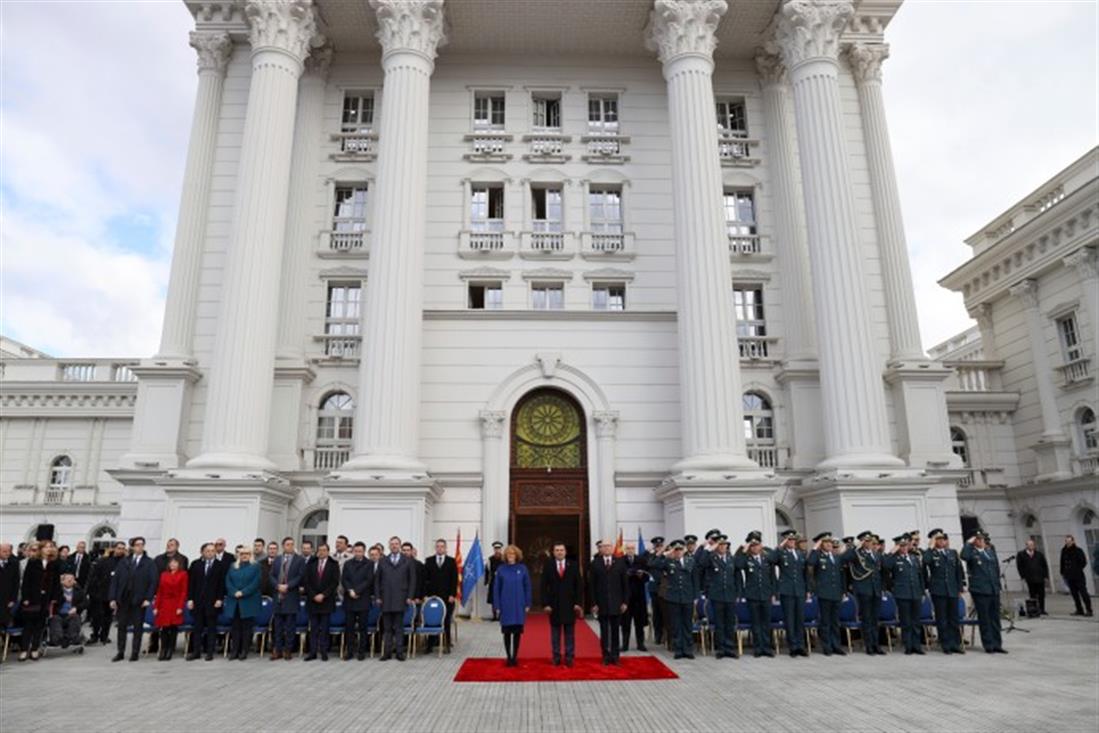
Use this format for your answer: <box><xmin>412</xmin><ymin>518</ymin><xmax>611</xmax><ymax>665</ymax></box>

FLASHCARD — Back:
<box><xmin>0</xmin><ymin>0</ymin><xmax>962</xmax><ymax>571</ymax></box>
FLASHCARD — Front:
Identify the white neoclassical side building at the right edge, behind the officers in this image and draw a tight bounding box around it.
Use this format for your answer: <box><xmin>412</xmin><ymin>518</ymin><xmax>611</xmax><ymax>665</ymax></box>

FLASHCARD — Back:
<box><xmin>931</xmin><ymin>148</ymin><xmax>1099</xmax><ymax>592</ymax></box>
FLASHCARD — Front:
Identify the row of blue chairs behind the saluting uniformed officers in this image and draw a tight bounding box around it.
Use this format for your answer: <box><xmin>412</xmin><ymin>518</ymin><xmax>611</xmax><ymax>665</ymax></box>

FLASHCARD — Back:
<box><xmin>685</xmin><ymin>591</ymin><xmax>977</xmax><ymax>654</ymax></box>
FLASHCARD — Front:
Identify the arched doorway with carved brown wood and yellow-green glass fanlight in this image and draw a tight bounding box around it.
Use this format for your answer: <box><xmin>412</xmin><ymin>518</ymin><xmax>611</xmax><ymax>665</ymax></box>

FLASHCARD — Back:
<box><xmin>508</xmin><ymin>389</ymin><xmax>589</xmax><ymax>608</ymax></box>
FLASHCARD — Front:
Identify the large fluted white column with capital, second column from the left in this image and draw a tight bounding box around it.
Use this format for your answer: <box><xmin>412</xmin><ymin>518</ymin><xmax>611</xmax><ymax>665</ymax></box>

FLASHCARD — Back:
<box><xmin>188</xmin><ymin>0</ymin><xmax>317</xmax><ymax>470</ymax></box>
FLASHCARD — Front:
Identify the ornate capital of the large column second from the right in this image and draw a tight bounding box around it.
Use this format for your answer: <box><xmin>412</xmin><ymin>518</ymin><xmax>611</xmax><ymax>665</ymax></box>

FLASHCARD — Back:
<box><xmin>775</xmin><ymin>0</ymin><xmax>855</xmax><ymax>70</ymax></box>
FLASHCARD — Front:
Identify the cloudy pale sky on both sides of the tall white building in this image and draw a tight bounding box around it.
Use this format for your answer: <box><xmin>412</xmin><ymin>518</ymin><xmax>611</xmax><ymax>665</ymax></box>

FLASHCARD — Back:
<box><xmin>0</xmin><ymin>0</ymin><xmax>1097</xmax><ymax>356</ymax></box>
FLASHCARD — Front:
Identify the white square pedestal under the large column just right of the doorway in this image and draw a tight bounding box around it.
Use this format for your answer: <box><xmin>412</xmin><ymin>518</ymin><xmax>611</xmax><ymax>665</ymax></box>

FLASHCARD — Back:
<box><xmin>656</xmin><ymin>469</ymin><xmax>782</xmax><ymax>544</ymax></box>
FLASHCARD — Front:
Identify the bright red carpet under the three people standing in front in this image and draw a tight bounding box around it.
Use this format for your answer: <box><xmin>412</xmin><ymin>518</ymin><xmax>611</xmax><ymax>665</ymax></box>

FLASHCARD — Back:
<box><xmin>454</xmin><ymin>613</ymin><xmax>678</xmax><ymax>682</ymax></box>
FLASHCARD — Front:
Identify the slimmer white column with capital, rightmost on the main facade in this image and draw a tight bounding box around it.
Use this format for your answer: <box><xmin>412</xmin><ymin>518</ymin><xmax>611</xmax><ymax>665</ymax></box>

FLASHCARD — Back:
<box><xmin>847</xmin><ymin>44</ymin><xmax>928</xmax><ymax>362</ymax></box>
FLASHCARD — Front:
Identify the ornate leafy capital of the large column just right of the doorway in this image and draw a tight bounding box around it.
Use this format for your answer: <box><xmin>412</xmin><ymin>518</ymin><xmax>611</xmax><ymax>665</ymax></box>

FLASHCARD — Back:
<box><xmin>645</xmin><ymin>0</ymin><xmax>729</xmax><ymax>64</ymax></box>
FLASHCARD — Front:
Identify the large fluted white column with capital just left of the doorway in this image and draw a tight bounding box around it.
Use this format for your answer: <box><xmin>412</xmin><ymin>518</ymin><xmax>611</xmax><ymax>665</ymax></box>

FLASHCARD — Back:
<box><xmin>343</xmin><ymin>0</ymin><xmax>445</xmax><ymax>477</ymax></box>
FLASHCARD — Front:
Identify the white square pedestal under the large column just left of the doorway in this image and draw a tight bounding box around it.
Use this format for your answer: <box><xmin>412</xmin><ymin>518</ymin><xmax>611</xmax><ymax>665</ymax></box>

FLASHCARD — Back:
<box><xmin>321</xmin><ymin>473</ymin><xmax>442</xmax><ymax>554</ymax></box>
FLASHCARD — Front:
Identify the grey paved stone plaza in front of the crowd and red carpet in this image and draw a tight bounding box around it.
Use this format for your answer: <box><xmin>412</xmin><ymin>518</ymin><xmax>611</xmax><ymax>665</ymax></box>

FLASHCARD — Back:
<box><xmin>0</xmin><ymin>597</ymin><xmax>1099</xmax><ymax>733</ymax></box>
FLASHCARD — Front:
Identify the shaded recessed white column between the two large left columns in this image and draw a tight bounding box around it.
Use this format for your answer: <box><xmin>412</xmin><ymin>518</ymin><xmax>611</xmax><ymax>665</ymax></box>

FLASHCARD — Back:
<box><xmin>276</xmin><ymin>46</ymin><xmax>332</xmax><ymax>360</ymax></box>
